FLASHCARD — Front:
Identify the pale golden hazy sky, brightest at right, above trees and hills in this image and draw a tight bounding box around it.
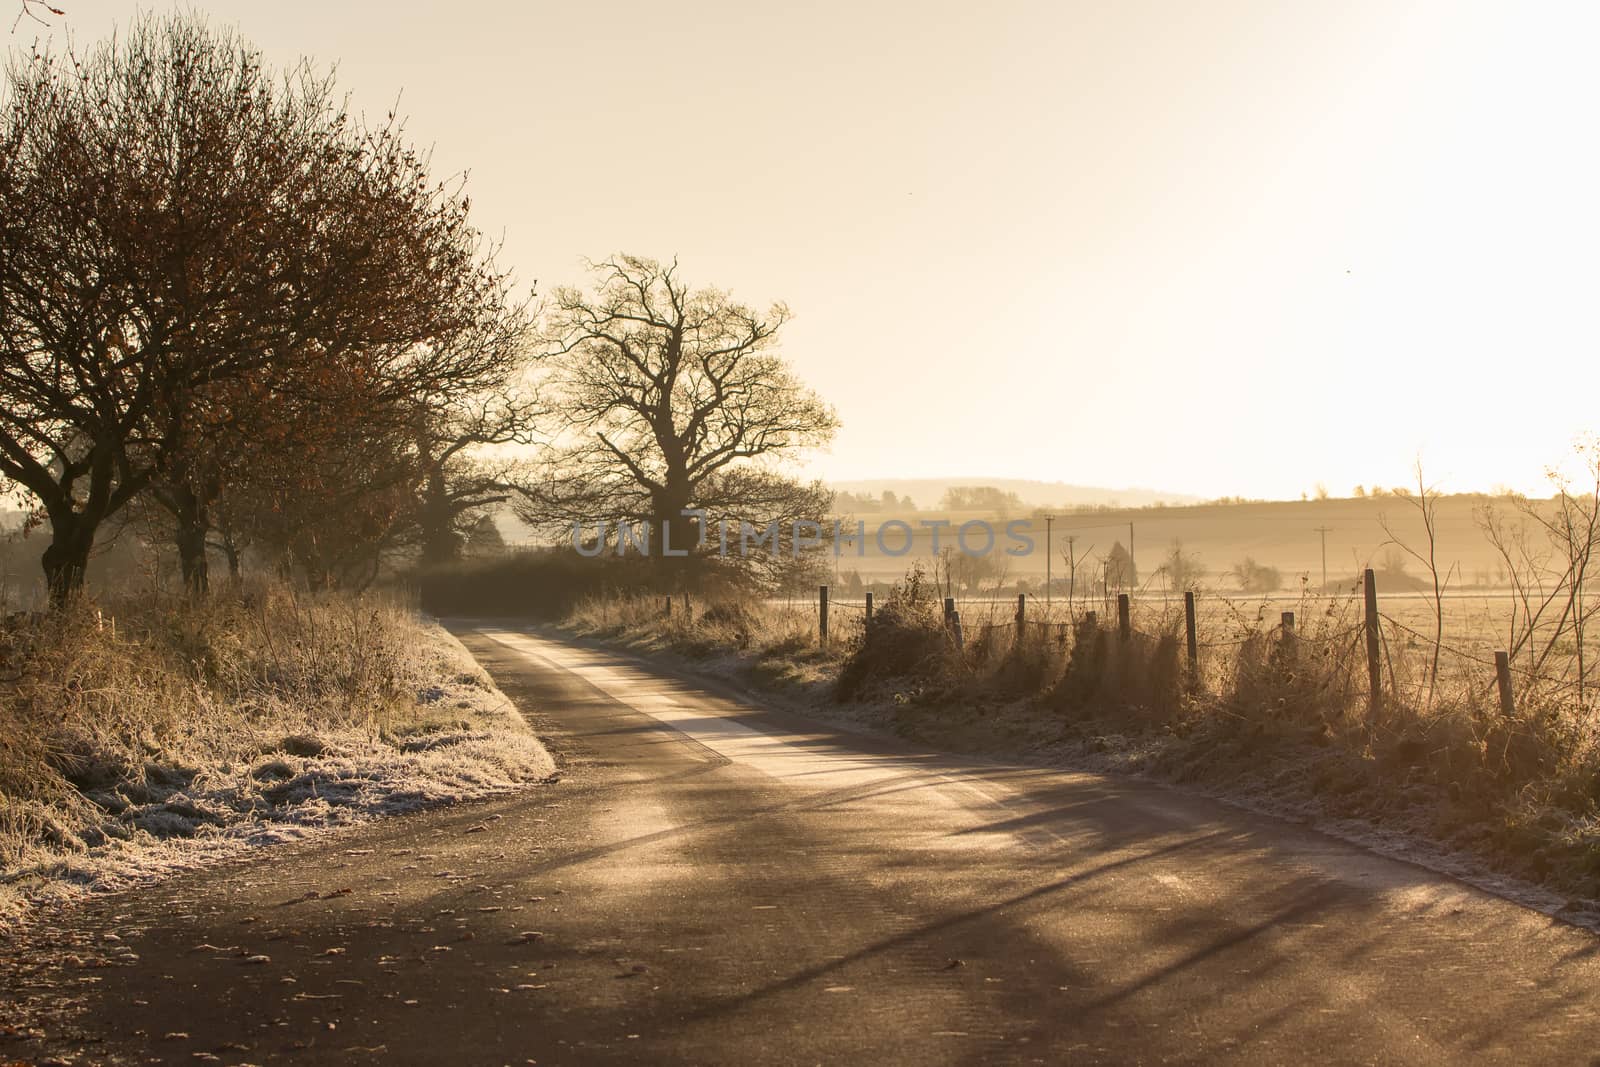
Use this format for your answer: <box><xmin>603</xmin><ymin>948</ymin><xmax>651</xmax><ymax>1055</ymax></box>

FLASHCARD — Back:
<box><xmin>25</xmin><ymin>0</ymin><xmax>1600</xmax><ymax>498</ymax></box>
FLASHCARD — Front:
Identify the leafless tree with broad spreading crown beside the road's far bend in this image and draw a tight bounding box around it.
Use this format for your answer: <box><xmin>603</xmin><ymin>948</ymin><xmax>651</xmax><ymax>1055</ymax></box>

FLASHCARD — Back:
<box><xmin>520</xmin><ymin>256</ymin><xmax>838</xmax><ymax>579</ymax></box>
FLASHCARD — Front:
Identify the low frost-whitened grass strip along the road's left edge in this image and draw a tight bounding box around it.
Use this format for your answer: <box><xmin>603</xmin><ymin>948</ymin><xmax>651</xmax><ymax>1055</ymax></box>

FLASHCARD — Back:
<box><xmin>0</xmin><ymin>622</ymin><xmax>554</xmax><ymax>923</ymax></box>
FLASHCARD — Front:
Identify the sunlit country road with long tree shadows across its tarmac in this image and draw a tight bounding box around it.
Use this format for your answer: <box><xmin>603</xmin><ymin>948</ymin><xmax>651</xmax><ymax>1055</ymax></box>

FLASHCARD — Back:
<box><xmin>0</xmin><ymin>621</ymin><xmax>1600</xmax><ymax>1067</ymax></box>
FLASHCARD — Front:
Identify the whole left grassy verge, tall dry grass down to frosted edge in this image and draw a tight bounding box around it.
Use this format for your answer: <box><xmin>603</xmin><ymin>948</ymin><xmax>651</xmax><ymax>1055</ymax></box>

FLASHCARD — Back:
<box><xmin>0</xmin><ymin>587</ymin><xmax>554</xmax><ymax>923</ymax></box>
